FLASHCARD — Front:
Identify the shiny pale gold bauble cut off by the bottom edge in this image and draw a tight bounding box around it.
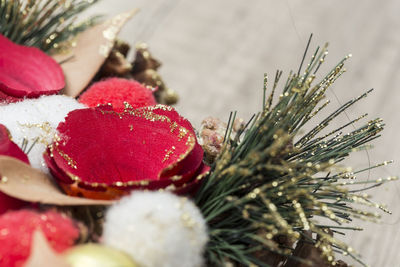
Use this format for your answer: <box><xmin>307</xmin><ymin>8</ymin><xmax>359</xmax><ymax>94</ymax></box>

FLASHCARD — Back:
<box><xmin>64</xmin><ymin>244</ymin><xmax>138</xmax><ymax>267</ymax></box>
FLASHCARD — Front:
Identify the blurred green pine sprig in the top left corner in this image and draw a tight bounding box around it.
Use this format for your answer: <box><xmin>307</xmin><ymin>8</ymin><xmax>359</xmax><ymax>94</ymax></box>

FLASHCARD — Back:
<box><xmin>0</xmin><ymin>0</ymin><xmax>98</xmax><ymax>52</ymax></box>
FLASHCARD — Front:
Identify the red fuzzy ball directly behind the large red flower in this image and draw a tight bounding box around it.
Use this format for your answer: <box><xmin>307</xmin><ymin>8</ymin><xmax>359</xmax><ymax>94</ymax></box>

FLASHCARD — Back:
<box><xmin>79</xmin><ymin>78</ymin><xmax>157</xmax><ymax>112</ymax></box>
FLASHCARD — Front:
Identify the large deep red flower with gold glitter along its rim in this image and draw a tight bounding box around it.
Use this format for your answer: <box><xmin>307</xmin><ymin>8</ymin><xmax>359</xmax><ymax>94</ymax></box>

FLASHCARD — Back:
<box><xmin>46</xmin><ymin>106</ymin><xmax>203</xmax><ymax>199</ymax></box>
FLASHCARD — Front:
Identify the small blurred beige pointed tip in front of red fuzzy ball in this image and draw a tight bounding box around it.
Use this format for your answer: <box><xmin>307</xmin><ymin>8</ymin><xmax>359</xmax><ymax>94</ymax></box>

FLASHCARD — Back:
<box><xmin>24</xmin><ymin>231</ymin><xmax>70</xmax><ymax>267</ymax></box>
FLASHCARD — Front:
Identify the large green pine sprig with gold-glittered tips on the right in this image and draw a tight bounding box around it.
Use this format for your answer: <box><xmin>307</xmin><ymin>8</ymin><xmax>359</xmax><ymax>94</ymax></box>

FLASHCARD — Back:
<box><xmin>195</xmin><ymin>38</ymin><xmax>395</xmax><ymax>266</ymax></box>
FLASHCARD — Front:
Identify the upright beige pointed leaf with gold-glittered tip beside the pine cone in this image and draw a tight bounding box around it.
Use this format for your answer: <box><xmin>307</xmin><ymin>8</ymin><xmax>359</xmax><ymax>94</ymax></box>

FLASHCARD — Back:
<box><xmin>53</xmin><ymin>9</ymin><xmax>138</xmax><ymax>97</ymax></box>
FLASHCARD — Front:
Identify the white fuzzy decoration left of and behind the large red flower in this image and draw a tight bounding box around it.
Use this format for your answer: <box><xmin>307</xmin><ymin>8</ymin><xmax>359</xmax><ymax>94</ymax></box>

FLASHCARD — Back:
<box><xmin>0</xmin><ymin>95</ymin><xmax>85</xmax><ymax>172</ymax></box>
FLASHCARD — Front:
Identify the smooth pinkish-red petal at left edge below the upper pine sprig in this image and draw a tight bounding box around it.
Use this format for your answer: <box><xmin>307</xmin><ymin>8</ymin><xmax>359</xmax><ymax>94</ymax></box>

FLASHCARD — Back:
<box><xmin>0</xmin><ymin>35</ymin><xmax>65</xmax><ymax>100</ymax></box>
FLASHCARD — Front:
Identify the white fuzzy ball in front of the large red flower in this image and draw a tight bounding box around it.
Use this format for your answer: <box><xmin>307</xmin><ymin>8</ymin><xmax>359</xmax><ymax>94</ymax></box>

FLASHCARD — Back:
<box><xmin>103</xmin><ymin>191</ymin><xmax>208</xmax><ymax>267</ymax></box>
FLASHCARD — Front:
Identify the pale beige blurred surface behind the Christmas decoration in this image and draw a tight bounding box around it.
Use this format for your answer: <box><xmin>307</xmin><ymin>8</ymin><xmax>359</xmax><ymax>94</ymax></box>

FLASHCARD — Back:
<box><xmin>88</xmin><ymin>0</ymin><xmax>400</xmax><ymax>267</ymax></box>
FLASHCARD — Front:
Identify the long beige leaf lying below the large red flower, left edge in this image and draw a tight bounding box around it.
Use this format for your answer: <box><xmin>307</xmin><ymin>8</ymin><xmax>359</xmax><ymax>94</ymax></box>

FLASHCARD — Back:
<box><xmin>0</xmin><ymin>156</ymin><xmax>113</xmax><ymax>206</ymax></box>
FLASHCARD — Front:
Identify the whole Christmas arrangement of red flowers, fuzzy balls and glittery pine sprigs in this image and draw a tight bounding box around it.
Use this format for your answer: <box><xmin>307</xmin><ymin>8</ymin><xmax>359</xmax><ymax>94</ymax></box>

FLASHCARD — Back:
<box><xmin>0</xmin><ymin>0</ymin><xmax>396</xmax><ymax>267</ymax></box>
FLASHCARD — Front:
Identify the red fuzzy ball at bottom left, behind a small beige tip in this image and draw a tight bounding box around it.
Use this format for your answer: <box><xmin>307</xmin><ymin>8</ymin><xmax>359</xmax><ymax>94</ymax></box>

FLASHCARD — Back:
<box><xmin>0</xmin><ymin>210</ymin><xmax>79</xmax><ymax>267</ymax></box>
